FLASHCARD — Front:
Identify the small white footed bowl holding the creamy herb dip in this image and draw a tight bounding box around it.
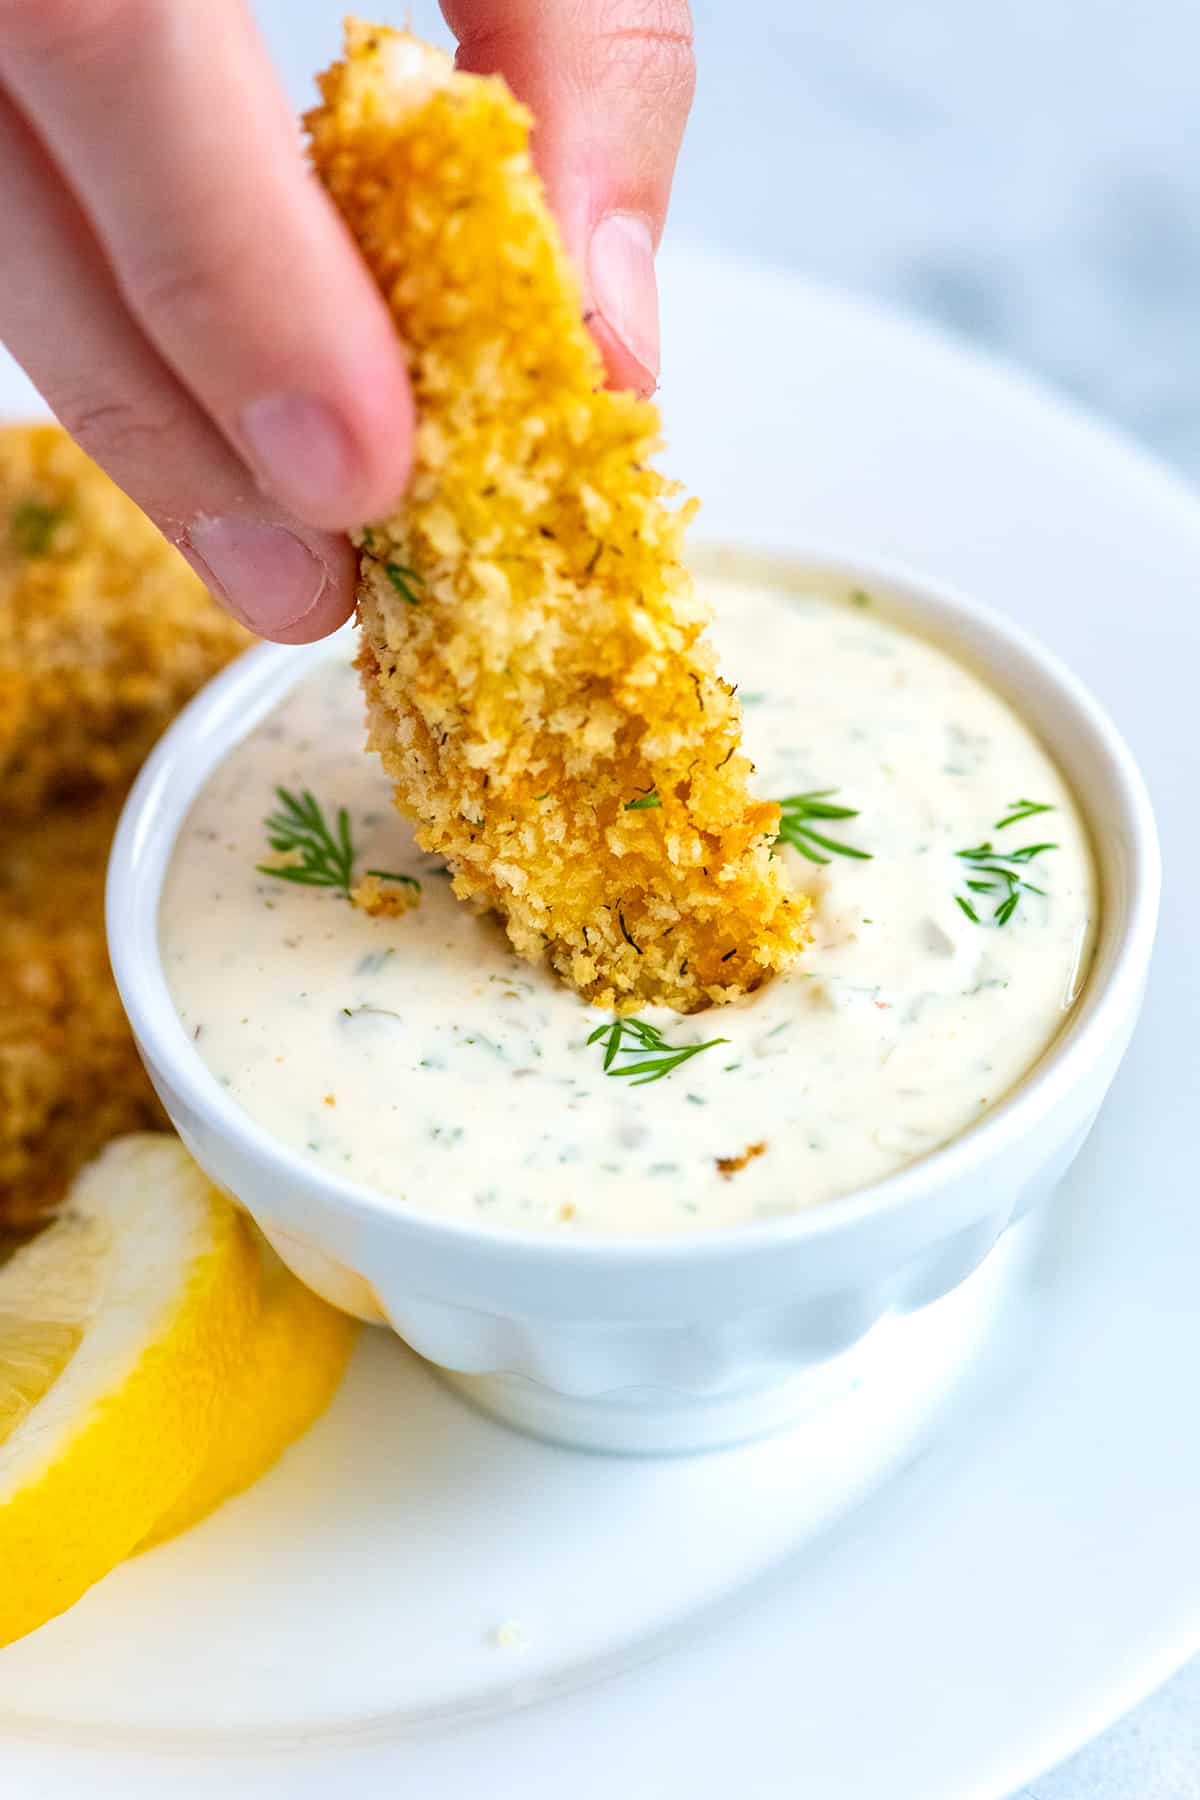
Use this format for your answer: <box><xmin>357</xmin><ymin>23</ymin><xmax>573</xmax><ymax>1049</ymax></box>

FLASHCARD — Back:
<box><xmin>108</xmin><ymin>554</ymin><xmax>1159</xmax><ymax>1451</ymax></box>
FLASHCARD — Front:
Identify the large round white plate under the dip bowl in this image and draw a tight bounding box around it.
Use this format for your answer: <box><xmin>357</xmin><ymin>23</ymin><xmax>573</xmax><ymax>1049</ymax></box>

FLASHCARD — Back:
<box><xmin>0</xmin><ymin>256</ymin><xmax>1200</xmax><ymax>1800</ymax></box>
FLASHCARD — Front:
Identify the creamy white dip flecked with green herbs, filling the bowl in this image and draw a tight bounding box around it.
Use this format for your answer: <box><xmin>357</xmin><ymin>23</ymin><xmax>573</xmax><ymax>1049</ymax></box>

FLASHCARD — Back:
<box><xmin>160</xmin><ymin>580</ymin><xmax>1097</xmax><ymax>1233</ymax></box>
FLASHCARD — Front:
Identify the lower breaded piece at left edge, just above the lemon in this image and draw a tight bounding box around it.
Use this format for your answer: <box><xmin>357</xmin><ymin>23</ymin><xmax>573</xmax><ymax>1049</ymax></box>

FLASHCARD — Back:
<box><xmin>0</xmin><ymin>790</ymin><xmax>164</xmax><ymax>1235</ymax></box>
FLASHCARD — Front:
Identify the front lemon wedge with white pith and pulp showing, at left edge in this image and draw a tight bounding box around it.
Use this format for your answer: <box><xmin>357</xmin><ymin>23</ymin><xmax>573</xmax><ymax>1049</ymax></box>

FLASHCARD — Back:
<box><xmin>0</xmin><ymin>1134</ymin><xmax>261</xmax><ymax>1645</ymax></box>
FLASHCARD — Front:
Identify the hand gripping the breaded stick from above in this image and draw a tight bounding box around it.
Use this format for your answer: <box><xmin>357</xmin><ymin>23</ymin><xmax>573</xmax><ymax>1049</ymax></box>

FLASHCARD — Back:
<box><xmin>0</xmin><ymin>0</ymin><xmax>693</xmax><ymax>643</ymax></box>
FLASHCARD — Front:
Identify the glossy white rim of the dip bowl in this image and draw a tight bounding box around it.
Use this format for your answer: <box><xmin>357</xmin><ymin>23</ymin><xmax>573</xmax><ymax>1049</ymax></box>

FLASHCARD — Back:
<box><xmin>106</xmin><ymin>533</ymin><xmax>1160</xmax><ymax>1269</ymax></box>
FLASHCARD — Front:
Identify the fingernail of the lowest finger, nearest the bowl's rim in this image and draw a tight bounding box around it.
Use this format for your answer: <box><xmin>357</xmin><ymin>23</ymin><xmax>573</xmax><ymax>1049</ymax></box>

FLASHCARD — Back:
<box><xmin>180</xmin><ymin>518</ymin><xmax>327</xmax><ymax>637</ymax></box>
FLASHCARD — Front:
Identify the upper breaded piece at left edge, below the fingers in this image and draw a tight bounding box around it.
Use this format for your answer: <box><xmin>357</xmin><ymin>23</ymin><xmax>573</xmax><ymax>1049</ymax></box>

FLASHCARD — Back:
<box><xmin>0</xmin><ymin>425</ymin><xmax>252</xmax><ymax>819</ymax></box>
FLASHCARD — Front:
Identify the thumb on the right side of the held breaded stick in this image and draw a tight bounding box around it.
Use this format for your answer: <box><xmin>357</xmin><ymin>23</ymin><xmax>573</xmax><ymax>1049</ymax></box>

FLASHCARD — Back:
<box><xmin>443</xmin><ymin>0</ymin><xmax>694</xmax><ymax>394</ymax></box>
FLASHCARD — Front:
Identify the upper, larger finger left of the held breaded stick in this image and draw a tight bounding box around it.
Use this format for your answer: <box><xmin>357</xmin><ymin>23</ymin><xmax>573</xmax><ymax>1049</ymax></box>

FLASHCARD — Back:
<box><xmin>0</xmin><ymin>0</ymin><xmax>412</xmax><ymax>529</ymax></box>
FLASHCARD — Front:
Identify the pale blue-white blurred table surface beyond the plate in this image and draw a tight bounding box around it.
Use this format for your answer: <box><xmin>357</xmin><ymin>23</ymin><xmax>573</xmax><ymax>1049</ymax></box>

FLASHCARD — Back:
<box><xmin>248</xmin><ymin>0</ymin><xmax>1200</xmax><ymax>1800</ymax></box>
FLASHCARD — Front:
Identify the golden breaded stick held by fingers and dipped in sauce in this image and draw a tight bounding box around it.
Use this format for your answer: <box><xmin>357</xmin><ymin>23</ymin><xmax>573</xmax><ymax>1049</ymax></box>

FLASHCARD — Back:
<box><xmin>308</xmin><ymin>23</ymin><xmax>808</xmax><ymax>1012</ymax></box>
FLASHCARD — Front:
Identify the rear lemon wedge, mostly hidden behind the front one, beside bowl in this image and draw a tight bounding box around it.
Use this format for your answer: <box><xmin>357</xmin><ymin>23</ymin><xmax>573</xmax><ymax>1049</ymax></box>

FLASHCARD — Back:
<box><xmin>139</xmin><ymin>1233</ymin><xmax>358</xmax><ymax>1550</ymax></box>
